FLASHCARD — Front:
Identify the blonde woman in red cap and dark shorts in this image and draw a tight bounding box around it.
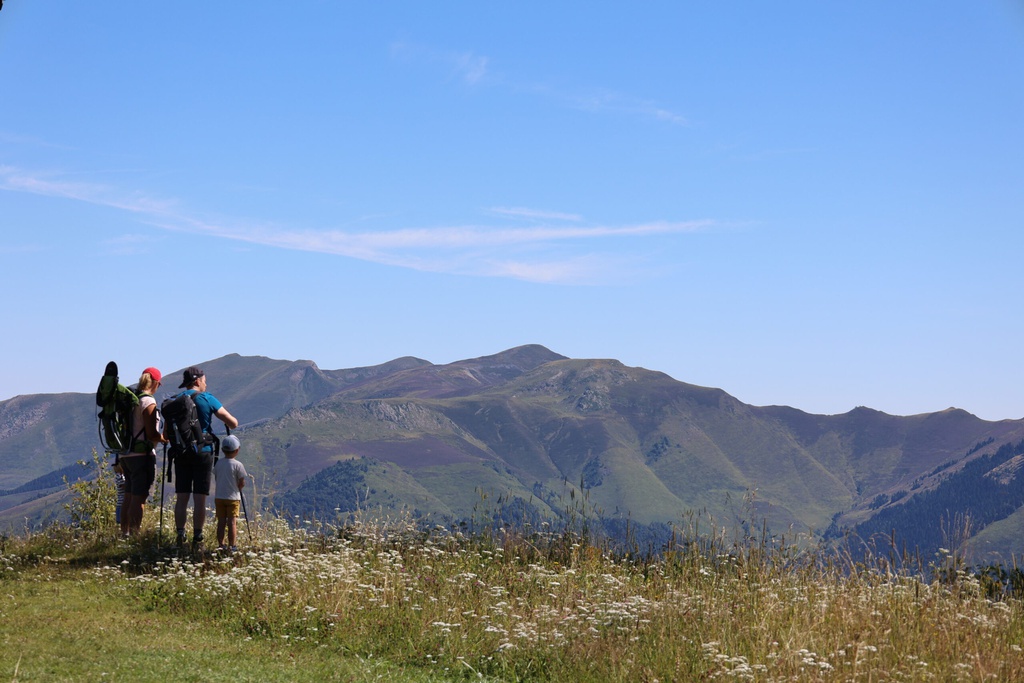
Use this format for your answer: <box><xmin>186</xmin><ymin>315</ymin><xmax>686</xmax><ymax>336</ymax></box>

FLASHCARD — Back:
<box><xmin>118</xmin><ymin>368</ymin><xmax>167</xmax><ymax>537</ymax></box>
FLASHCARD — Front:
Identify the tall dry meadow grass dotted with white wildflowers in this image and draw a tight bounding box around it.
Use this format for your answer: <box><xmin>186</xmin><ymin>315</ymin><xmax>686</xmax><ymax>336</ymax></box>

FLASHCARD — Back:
<box><xmin>0</xmin><ymin>473</ymin><xmax>1024</xmax><ymax>681</ymax></box>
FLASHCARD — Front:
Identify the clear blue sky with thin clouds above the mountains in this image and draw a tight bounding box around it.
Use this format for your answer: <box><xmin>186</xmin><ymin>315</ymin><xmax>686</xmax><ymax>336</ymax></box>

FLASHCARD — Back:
<box><xmin>0</xmin><ymin>0</ymin><xmax>1024</xmax><ymax>422</ymax></box>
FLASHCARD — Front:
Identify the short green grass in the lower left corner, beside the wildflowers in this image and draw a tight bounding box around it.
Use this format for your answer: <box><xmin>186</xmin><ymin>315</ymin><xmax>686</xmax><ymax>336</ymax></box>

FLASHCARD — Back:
<box><xmin>0</xmin><ymin>565</ymin><xmax>432</xmax><ymax>683</ymax></box>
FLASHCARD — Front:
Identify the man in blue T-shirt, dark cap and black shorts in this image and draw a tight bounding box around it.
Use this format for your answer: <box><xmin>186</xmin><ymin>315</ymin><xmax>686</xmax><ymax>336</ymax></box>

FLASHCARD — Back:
<box><xmin>174</xmin><ymin>367</ymin><xmax>239</xmax><ymax>549</ymax></box>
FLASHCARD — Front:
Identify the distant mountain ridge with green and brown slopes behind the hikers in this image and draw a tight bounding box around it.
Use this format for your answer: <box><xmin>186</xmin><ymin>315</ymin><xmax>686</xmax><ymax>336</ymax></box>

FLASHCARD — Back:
<box><xmin>0</xmin><ymin>345</ymin><xmax>1024</xmax><ymax>559</ymax></box>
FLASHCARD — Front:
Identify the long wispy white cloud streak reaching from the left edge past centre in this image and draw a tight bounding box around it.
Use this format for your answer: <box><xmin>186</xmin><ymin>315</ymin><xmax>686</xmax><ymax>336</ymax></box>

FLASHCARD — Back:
<box><xmin>0</xmin><ymin>166</ymin><xmax>714</xmax><ymax>284</ymax></box>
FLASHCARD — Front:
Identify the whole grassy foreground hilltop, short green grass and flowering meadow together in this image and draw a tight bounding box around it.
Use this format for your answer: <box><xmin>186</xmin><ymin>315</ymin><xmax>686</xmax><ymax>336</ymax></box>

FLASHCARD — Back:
<box><xmin>0</xmin><ymin>480</ymin><xmax>1024</xmax><ymax>682</ymax></box>
